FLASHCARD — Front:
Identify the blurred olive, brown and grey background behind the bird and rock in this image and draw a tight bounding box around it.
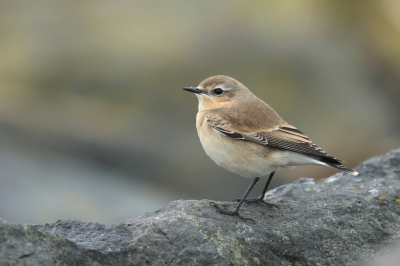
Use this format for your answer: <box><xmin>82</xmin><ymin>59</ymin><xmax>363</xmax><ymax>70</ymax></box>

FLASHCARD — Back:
<box><xmin>0</xmin><ymin>0</ymin><xmax>400</xmax><ymax>225</ymax></box>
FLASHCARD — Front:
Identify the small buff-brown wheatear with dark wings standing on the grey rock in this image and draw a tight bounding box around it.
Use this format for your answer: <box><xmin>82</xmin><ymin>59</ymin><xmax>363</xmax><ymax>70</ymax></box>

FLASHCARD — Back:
<box><xmin>183</xmin><ymin>76</ymin><xmax>358</xmax><ymax>222</ymax></box>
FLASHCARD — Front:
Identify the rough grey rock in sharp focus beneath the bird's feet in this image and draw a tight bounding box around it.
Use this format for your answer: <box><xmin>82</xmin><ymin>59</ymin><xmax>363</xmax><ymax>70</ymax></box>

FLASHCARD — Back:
<box><xmin>0</xmin><ymin>149</ymin><xmax>400</xmax><ymax>265</ymax></box>
